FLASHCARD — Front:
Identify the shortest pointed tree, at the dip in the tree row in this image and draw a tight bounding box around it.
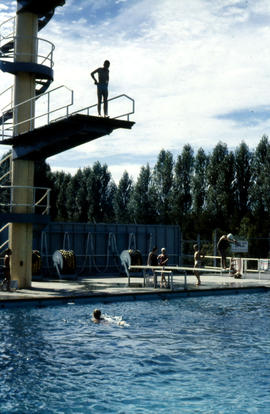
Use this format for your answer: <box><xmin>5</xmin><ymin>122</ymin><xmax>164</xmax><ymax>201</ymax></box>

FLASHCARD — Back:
<box><xmin>113</xmin><ymin>171</ymin><xmax>133</xmax><ymax>223</ymax></box>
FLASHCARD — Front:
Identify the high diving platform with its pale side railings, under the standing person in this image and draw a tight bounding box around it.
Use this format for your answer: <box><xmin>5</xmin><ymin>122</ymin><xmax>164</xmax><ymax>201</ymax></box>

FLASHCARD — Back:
<box><xmin>0</xmin><ymin>85</ymin><xmax>135</xmax><ymax>161</ymax></box>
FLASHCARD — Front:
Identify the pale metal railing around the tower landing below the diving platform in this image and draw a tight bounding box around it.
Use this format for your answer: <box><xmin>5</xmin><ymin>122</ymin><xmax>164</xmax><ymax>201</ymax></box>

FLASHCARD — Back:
<box><xmin>0</xmin><ymin>185</ymin><xmax>51</xmax><ymax>215</ymax></box>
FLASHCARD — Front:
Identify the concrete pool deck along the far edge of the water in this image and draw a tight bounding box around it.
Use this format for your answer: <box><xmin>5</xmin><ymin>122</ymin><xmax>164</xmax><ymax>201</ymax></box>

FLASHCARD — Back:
<box><xmin>0</xmin><ymin>274</ymin><xmax>270</xmax><ymax>307</ymax></box>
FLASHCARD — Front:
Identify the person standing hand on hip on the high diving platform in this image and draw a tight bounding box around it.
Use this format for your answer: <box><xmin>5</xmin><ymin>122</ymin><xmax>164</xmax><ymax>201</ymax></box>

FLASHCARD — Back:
<box><xmin>91</xmin><ymin>60</ymin><xmax>110</xmax><ymax>117</ymax></box>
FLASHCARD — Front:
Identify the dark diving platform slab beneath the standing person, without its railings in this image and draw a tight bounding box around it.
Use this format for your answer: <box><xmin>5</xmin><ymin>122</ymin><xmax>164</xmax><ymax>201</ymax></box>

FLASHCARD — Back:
<box><xmin>0</xmin><ymin>114</ymin><xmax>135</xmax><ymax>160</ymax></box>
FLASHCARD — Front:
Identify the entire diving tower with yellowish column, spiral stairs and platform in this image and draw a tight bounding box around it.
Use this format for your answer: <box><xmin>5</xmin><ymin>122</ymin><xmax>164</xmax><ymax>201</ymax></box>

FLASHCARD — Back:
<box><xmin>0</xmin><ymin>0</ymin><xmax>135</xmax><ymax>288</ymax></box>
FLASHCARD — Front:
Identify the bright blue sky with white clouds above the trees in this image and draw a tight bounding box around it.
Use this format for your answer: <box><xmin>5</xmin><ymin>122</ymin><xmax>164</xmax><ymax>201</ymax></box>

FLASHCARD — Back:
<box><xmin>0</xmin><ymin>0</ymin><xmax>270</xmax><ymax>182</ymax></box>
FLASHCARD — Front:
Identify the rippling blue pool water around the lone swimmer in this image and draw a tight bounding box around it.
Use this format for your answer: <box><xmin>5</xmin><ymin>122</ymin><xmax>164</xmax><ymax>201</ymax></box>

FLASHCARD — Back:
<box><xmin>0</xmin><ymin>293</ymin><xmax>270</xmax><ymax>414</ymax></box>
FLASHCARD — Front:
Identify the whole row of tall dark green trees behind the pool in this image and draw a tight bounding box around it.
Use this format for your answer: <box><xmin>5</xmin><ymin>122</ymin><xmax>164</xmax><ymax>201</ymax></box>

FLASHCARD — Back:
<box><xmin>0</xmin><ymin>135</ymin><xmax>270</xmax><ymax>253</ymax></box>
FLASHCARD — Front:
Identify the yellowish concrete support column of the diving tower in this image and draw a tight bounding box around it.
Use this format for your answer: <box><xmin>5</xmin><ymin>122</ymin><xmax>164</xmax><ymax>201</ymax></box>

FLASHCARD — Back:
<box><xmin>9</xmin><ymin>8</ymin><xmax>38</xmax><ymax>288</ymax></box>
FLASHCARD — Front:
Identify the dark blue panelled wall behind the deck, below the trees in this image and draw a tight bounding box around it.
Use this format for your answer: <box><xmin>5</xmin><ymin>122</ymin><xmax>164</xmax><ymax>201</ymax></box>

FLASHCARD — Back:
<box><xmin>33</xmin><ymin>222</ymin><xmax>181</xmax><ymax>274</ymax></box>
